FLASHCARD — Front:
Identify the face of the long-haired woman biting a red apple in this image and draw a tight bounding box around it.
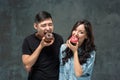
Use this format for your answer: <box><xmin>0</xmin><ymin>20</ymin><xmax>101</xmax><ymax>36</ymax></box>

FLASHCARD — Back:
<box><xmin>72</xmin><ymin>24</ymin><xmax>87</xmax><ymax>45</ymax></box>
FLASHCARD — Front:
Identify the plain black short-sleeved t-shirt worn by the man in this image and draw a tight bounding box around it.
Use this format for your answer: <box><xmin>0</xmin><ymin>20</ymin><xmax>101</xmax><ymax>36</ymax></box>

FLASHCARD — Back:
<box><xmin>22</xmin><ymin>33</ymin><xmax>63</xmax><ymax>80</ymax></box>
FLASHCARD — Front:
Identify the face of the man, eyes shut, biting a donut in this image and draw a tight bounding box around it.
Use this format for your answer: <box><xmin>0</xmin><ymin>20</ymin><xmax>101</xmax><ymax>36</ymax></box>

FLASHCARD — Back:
<box><xmin>34</xmin><ymin>18</ymin><xmax>54</xmax><ymax>37</ymax></box>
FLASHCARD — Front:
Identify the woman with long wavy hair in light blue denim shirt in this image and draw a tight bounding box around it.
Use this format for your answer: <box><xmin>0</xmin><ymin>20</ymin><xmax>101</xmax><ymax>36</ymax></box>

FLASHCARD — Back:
<box><xmin>59</xmin><ymin>20</ymin><xmax>96</xmax><ymax>80</ymax></box>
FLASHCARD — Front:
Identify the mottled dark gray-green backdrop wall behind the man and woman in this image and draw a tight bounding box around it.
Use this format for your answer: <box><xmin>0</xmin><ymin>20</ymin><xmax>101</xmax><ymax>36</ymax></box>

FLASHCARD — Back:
<box><xmin>0</xmin><ymin>0</ymin><xmax>120</xmax><ymax>80</ymax></box>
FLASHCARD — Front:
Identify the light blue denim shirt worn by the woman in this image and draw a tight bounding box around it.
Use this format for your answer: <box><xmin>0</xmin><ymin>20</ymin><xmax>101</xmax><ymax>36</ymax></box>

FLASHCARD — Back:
<box><xmin>59</xmin><ymin>44</ymin><xmax>96</xmax><ymax>80</ymax></box>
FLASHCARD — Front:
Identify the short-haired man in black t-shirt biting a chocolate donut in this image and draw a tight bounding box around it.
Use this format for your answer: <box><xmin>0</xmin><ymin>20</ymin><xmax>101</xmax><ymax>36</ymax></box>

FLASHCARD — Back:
<box><xmin>22</xmin><ymin>11</ymin><xmax>63</xmax><ymax>80</ymax></box>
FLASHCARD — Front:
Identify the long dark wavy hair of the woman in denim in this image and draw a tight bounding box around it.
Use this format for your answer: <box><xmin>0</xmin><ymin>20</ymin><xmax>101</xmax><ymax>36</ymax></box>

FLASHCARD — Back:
<box><xmin>62</xmin><ymin>20</ymin><xmax>96</xmax><ymax>64</ymax></box>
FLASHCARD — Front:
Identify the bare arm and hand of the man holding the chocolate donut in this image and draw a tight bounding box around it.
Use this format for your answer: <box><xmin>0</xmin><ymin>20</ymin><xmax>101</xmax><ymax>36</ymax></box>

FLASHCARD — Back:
<box><xmin>22</xmin><ymin>38</ymin><xmax>54</xmax><ymax>72</ymax></box>
